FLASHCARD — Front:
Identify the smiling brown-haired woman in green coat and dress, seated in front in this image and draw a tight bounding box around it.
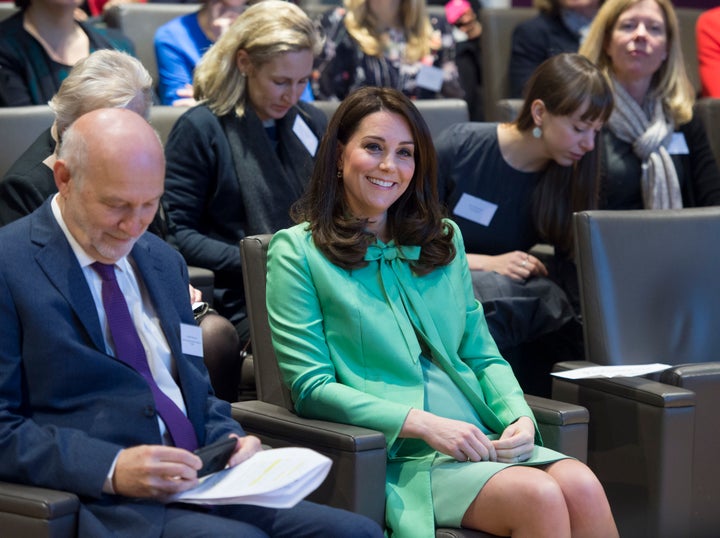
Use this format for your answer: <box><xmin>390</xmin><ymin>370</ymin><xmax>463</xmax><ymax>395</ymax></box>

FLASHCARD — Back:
<box><xmin>267</xmin><ymin>87</ymin><xmax>617</xmax><ymax>538</ymax></box>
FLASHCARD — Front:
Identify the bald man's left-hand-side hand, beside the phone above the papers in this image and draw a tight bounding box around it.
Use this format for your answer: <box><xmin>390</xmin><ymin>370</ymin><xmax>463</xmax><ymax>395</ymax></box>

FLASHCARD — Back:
<box><xmin>113</xmin><ymin>445</ymin><xmax>202</xmax><ymax>500</ymax></box>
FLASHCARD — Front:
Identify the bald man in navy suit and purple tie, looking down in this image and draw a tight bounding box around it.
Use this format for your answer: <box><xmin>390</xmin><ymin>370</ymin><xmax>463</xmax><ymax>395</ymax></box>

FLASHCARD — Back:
<box><xmin>0</xmin><ymin>109</ymin><xmax>382</xmax><ymax>538</ymax></box>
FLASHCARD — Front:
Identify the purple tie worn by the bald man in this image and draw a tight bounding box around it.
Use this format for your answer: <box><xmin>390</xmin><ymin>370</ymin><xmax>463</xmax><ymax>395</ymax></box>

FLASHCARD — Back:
<box><xmin>90</xmin><ymin>262</ymin><xmax>198</xmax><ymax>450</ymax></box>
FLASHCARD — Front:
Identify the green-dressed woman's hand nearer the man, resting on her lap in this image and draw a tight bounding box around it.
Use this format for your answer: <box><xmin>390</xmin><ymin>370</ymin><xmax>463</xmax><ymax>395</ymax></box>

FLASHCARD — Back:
<box><xmin>400</xmin><ymin>409</ymin><xmax>497</xmax><ymax>461</ymax></box>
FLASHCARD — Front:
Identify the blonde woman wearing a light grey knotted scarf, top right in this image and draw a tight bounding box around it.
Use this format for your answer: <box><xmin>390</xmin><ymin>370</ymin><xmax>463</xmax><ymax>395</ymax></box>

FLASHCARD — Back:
<box><xmin>580</xmin><ymin>0</ymin><xmax>720</xmax><ymax>209</ymax></box>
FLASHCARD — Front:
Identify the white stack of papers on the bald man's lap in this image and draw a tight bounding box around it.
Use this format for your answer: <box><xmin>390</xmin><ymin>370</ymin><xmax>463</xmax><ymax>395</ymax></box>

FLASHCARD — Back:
<box><xmin>172</xmin><ymin>447</ymin><xmax>332</xmax><ymax>508</ymax></box>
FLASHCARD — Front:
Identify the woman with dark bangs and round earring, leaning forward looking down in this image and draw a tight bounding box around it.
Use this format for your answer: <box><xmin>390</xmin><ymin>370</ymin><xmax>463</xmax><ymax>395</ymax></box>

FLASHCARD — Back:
<box><xmin>435</xmin><ymin>53</ymin><xmax>613</xmax><ymax>394</ymax></box>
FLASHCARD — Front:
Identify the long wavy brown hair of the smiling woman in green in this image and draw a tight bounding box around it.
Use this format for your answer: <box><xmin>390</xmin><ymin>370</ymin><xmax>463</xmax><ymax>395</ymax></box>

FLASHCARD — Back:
<box><xmin>291</xmin><ymin>86</ymin><xmax>455</xmax><ymax>274</ymax></box>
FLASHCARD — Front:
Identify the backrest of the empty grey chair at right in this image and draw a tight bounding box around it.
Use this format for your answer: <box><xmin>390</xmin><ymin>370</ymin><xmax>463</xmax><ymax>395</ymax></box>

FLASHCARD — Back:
<box><xmin>574</xmin><ymin>208</ymin><xmax>720</xmax><ymax>364</ymax></box>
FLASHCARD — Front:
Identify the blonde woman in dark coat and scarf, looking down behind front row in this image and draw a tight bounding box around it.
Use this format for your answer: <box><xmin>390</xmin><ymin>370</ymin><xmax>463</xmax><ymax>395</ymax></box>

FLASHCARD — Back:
<box><xmin>164</xmin><ymin>0</ymin><xmax>327</xmax><ymax>342</ymax></box>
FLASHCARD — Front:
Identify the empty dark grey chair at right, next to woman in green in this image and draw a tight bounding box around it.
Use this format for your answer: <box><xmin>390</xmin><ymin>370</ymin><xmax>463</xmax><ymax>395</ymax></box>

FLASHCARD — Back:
<box><xmin>553</xmin><ymin>208</ymin><xmax>720</xmax><ymax>537</ymax></box>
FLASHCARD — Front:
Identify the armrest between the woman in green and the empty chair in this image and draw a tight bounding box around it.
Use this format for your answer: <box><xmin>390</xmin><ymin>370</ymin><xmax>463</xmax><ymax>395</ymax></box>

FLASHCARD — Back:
<box><xmin>525</xmin><ymin>394</ymin><xmax>590</xmax><ymax>462</ymax></box>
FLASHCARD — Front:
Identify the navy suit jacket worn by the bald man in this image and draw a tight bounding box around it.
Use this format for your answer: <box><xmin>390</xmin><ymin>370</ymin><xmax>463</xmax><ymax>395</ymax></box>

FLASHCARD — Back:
<box><xmin>0</xmin><ymin>200</ymin><xmax>244</xmax><ymax>537</ymax></box>
